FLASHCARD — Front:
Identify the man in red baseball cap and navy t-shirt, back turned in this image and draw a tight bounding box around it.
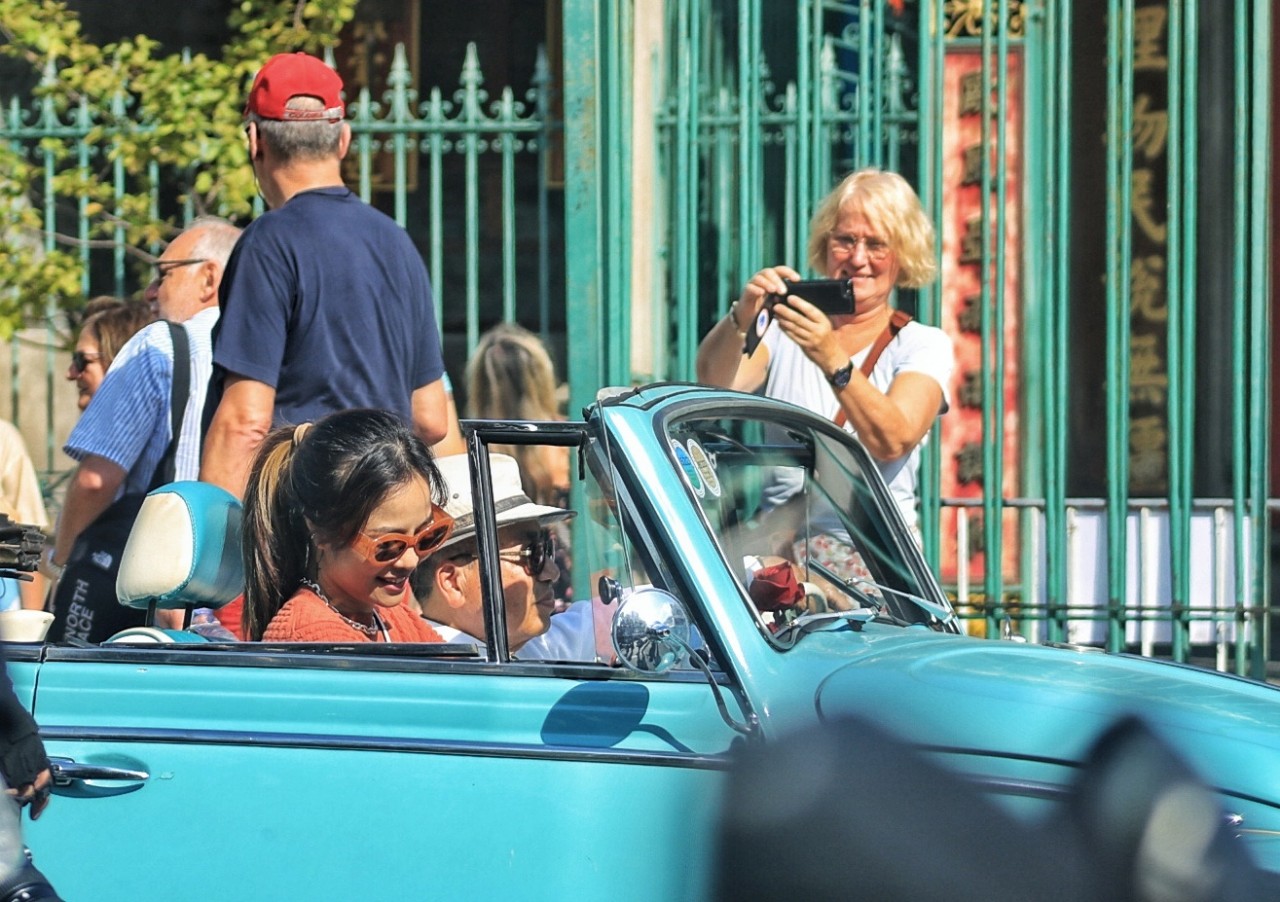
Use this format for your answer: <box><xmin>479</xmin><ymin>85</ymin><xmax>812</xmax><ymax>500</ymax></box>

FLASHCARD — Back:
<box><xmin>200</xmin><ymin>54</ymin><xmax>447</xmax><ymax>495</ymax></box>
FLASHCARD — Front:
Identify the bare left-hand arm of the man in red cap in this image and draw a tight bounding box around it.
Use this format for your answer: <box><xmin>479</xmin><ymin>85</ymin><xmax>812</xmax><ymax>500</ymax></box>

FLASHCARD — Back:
<box><xmin>200</xmin><ymin>375</ymin><xmax>275</xmax><ymax>498</ymax></box>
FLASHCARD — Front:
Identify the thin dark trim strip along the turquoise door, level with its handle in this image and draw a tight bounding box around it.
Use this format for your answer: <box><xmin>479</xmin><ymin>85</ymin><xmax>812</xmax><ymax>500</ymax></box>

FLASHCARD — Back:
<box><xmin>40</xmin><ymin>724</ymin><xmax>730</xmax><ymax>770</ymax></box>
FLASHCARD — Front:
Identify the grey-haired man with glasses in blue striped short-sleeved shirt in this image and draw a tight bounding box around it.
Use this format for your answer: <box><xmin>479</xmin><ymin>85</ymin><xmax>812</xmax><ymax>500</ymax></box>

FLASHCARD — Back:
<box><xmin>45</xmin><ymin>216</ymin><xmax>241</xmax><ymax>629</ymax></box>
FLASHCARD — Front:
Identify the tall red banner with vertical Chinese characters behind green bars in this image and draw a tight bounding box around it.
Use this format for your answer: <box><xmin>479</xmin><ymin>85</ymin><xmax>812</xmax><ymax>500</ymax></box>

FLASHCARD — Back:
<box><xmin>940</xmin><ymin>49</ymin><xmax>1023</xmax><ymax>581</ymax></box>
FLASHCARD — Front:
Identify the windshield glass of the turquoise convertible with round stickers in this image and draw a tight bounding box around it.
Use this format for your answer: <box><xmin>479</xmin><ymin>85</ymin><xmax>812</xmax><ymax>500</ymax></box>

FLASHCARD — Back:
<box><xmin>668</xmin><ymin>416</ymin><xmax>947</xmax><ymax>645</ymax></box>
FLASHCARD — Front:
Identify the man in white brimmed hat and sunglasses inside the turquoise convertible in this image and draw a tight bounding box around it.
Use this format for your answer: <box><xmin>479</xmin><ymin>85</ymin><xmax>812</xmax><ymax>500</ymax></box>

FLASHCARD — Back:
<box><xmin>412</xmin><ymin>454</ymin><xmax>595</xmax><ymax>661</ymax></box>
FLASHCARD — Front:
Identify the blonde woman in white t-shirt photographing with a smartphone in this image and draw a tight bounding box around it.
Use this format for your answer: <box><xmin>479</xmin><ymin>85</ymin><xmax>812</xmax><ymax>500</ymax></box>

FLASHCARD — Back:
<box><xmin>698</xmin><ymin>169</ymin><xmax>955</xmax><ymax>530</ymax></box>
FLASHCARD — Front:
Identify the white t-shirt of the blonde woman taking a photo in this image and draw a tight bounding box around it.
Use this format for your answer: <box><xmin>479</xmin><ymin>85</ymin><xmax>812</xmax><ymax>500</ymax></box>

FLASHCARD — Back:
<box><xmin>763</xmin><ymin>320</ymin><xmax>955</xmax><ymax>528</ymax></box>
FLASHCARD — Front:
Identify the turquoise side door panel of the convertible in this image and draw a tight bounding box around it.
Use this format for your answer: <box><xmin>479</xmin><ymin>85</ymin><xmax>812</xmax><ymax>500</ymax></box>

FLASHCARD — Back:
<box><xmin>28</xmin><ymin>655</ymin><xmax>733</xmax><ymax>899</ymax></box>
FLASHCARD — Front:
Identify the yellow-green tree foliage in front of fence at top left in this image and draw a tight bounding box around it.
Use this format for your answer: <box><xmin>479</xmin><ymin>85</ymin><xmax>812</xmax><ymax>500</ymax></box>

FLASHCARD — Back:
<box><xmin>0</xmin><ymin>0</ymin><xmax>358</xmax><ymax>335</ymax></box>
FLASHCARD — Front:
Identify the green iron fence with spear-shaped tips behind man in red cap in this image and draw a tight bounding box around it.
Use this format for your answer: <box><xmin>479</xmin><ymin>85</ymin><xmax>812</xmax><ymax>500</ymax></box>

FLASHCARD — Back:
<box><xmin>0</xmin><ymin>39</ymin><xmax>563</xmax><ymax>486</ymax></box>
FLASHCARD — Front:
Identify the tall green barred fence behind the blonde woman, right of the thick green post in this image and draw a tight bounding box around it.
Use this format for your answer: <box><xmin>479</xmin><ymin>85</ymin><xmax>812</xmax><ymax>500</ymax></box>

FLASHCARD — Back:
<box><xmin>646</xmin><ymin>0</ymin><xmax>1275</xmax><ymax>676</ymax></box>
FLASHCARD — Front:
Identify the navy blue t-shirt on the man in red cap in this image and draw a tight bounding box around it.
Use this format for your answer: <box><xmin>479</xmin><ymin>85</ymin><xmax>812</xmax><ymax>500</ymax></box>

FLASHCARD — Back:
<box><xmin>206</xmin><ymin>187</ymin><xmax>444</xmax><ymax>426</ymax></box>
